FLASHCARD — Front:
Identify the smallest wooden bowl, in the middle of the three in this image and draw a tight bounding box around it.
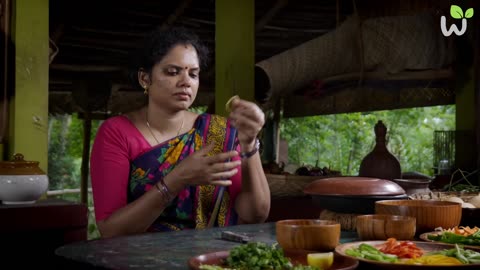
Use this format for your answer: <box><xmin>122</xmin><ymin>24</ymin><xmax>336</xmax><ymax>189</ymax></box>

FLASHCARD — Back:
<box><xmin>357</xmin><ymin>215</ymin><xmax>416</xmax><ymax>240</ymax></box>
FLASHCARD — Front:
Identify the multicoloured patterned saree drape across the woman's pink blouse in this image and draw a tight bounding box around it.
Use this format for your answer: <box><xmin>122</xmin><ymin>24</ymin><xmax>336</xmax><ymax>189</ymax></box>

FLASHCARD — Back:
<box><xmin>128</xmin><ymin>114</ymin><xmax>240</xmax><ymax>231</ymax></box>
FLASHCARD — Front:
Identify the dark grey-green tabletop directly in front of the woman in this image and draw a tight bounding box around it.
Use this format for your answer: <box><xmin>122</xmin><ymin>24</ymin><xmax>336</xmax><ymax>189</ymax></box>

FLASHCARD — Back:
<box><xmin>56</xmin><ymin>222</ymin><xmax>357</xmax><ymax>269</ymax></box>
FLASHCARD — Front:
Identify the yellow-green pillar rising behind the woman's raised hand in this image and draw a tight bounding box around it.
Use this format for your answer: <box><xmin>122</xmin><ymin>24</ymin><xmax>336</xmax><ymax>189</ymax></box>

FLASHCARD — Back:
<box><xmin>215</xmin><ymin>0</ymin><xmax>255</xmax><ymax>116</ymax></box>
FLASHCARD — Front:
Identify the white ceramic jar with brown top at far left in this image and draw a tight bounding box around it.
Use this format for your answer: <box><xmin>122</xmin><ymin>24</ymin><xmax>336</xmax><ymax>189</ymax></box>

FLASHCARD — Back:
<box><xmin>0</xmin><ymin>154</ymin><xmax>48</xmax><ymax>204</ymax></box>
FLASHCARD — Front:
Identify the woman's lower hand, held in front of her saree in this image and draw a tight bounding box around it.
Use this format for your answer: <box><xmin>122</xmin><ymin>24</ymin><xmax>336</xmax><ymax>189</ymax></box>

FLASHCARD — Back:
<box><xmin>168</xmin><ymin>144</ymin><xmax>241</xmax><ymax>186</ymax></box>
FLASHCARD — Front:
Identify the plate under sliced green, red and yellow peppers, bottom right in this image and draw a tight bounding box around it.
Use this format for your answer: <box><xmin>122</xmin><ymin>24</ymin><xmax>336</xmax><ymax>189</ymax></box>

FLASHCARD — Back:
<box><xmin>335</xmin><ymin>241</ymin><xmax>480</xmax><ymax>270</ymax></box>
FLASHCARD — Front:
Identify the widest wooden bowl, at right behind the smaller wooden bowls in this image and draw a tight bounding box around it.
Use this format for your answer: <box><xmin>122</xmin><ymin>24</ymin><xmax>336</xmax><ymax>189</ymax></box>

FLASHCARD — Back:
<box><xmin>375</xmin><ymin>200</ymin><xmax>462</xmax><ymax>235</ymax></box>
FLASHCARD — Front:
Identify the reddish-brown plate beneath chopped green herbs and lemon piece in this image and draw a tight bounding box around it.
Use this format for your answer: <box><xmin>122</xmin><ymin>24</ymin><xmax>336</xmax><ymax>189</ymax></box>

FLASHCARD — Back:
<box><xmin>188</xmin><ymin>250</ymin><xmax>358</xmax><ymax>270</ymax></box>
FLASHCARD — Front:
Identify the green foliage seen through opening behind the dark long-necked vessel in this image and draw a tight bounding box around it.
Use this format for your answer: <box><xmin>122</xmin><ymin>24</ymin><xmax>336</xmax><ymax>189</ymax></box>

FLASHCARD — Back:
<box><xmin>280</xmin><ymin>105</ymin><xmax>455</xmax><ymax>175</ymax></box>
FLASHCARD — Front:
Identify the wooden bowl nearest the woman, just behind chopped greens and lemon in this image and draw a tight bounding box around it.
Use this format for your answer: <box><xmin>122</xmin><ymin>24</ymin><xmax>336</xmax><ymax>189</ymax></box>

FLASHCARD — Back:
<box><xmin>275</xmin><ymin>219</ymin><xmax>340</xmax><ymax>251</ymax></box>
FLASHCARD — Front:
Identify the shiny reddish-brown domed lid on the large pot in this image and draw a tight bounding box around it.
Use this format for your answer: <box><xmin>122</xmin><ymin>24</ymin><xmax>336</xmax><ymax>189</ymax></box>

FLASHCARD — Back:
<box><xmin>303</xmin><ymin>176</ymin><xmax>405</xmax><ymax>196</ymax></box>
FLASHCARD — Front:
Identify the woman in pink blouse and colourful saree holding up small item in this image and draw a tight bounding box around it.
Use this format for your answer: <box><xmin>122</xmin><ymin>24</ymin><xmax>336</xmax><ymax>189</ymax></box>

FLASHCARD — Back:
<box><xmin>91</xmin><ymin>28</ymin><xmax>270</xmax><ymax>237</ymax></box>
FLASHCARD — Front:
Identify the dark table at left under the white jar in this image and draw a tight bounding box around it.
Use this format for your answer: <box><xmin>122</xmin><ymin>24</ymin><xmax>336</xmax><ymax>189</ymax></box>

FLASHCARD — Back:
<box><xmin>0</xmin><ymin>199</ymin><xmax>88</xmax><ymax>269</ymax></box>
